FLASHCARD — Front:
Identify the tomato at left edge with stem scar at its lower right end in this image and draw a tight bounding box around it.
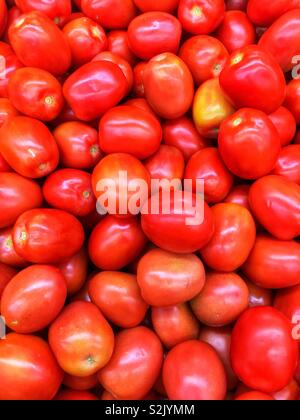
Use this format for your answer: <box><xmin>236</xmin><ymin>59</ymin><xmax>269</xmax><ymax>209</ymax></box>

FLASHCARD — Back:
<box><xmin>0</xmin><ymin>116</ymin><xmax>59</xmax><ymax>178</ymax></box>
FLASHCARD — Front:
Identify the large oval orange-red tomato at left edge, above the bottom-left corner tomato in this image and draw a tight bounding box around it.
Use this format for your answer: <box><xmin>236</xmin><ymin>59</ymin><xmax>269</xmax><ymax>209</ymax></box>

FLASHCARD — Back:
<box><xmin>1</xmin><ymin>265</ymin><xmax>67</xmax><ymax>334</ymax></box>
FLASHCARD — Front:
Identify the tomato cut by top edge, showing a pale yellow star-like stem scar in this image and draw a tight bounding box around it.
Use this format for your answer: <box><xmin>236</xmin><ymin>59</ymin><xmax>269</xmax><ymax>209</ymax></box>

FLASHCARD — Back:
<box><xmin>178</xmin><ymin>0</ymin><xmax>225</xmax><ymax>35</ymax></box>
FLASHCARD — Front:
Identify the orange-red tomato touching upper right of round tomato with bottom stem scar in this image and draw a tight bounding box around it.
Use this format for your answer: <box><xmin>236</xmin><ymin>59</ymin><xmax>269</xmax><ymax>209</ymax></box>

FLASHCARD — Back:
<box><xmin>89</xmin><ymin>271</ymin><xmax>148</xmax><ymax>328</ymax></box>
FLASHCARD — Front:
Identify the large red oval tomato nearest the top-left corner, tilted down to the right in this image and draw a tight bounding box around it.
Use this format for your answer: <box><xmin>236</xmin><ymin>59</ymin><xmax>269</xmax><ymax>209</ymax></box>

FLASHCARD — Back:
<box><xmin>9</xmin><ymin>11</ymin><xmax>71</xmax><ymax>76</ymax></box>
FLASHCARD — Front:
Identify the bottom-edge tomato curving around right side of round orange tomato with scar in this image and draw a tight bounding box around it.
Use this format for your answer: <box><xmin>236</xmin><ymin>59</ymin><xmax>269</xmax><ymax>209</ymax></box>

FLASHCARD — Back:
<box><xmin>98</xmin><ymin>327</ymin><xmax>163</xmax><ymax>400</ymax></box>
